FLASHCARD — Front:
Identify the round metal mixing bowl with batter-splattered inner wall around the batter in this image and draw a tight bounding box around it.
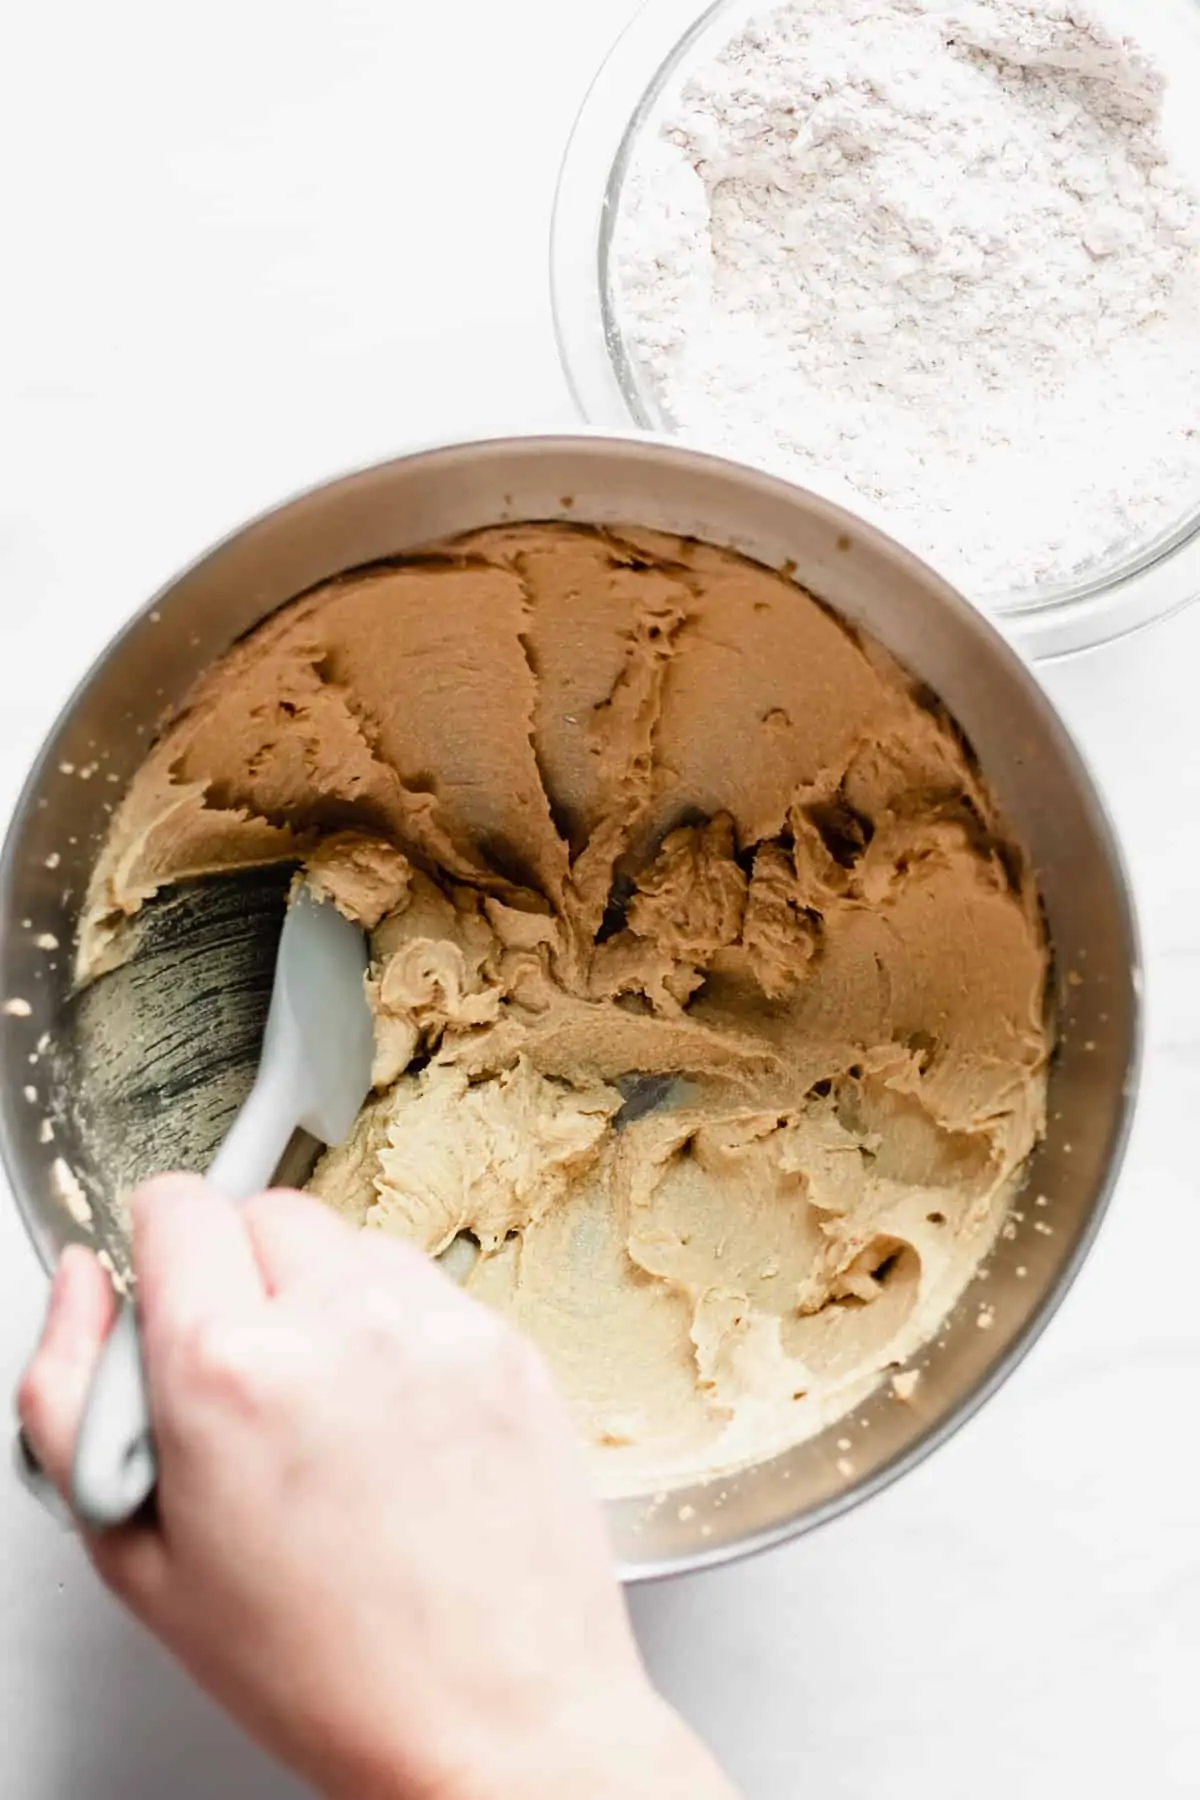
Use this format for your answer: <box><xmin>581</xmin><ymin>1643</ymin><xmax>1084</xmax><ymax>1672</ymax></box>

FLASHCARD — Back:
<box><xmin>0</xmin><ymin>436</ymin><xmax>1139</xmax><ymax>1579</ymax></box>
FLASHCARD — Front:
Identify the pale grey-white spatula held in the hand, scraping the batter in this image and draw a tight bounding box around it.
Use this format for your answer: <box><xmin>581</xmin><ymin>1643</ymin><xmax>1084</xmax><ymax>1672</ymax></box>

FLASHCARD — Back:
<box><xmin>72</xmin><ymin>887</ymin><xmax>374</xmax><ymax>1530</ymax></box>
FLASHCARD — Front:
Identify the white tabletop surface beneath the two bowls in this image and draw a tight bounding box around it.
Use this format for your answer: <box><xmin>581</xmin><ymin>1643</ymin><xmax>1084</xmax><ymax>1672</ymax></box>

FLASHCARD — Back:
<box><xmin>0</xmin><ymin>0</ymin><xmax>1200</xmax><ymax>1800</ymax></box>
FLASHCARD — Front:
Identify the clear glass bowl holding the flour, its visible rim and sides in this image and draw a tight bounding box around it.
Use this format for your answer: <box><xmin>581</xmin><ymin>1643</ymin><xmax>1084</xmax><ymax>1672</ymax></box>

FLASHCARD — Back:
<box><xmin>551</xmin><ymin>0</ymin><xmax>1200</xmax><ymax>661</ymax></box>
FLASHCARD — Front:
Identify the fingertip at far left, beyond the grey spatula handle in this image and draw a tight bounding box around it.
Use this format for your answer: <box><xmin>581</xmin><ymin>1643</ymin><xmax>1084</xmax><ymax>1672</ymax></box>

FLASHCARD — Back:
<box><xmin>16</xmin><ymin>1244</ymin><xmax>117</xmax><ymax>1496</ymax></box>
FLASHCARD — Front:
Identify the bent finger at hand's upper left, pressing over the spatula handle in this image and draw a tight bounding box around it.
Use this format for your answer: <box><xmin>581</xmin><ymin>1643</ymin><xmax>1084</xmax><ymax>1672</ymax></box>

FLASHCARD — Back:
<box><xmin>131</xmin><ymin>1175</ymin><xmax>264</xmax><ymax>1373</ymax></box>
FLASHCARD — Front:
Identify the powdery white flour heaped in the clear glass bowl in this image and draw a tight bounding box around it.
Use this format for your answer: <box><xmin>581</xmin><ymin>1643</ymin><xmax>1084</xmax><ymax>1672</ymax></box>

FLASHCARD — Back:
<box><xmin>612</xmin><ymin>0</ymin><xmax>1200</xmax><ymax>596</ymax></box>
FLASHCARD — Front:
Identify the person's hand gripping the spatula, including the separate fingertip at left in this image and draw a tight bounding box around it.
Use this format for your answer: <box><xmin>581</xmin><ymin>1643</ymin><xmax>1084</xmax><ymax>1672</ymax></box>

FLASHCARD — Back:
<box><xmin>18</xmin><ymin>1175</ymin><xmax>730</xmax><ymax>1800</ymax></box>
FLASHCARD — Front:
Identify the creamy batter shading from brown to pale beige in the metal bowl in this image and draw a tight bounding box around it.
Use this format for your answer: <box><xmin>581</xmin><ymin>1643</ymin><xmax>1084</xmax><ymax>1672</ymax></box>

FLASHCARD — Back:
<box><xmin>81</xmin><ymin>526</ymin><xmax>1049</xmax><ymax>1492</ymax></box>
